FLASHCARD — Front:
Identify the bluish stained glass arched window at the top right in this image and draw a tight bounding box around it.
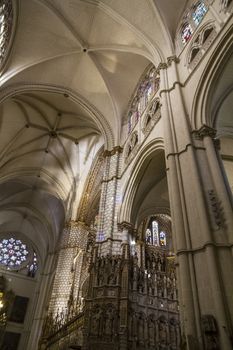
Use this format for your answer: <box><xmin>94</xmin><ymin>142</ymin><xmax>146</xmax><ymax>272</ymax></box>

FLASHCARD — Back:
<box><xmin>177</xmin><ymin>0</ymin><xmax>208</xmax><ymax>46</ymax></box>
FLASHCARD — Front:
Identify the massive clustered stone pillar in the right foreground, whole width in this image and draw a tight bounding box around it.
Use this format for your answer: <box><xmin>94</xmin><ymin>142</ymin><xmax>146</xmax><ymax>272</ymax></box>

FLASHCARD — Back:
<box><xmin>161</xmin><ymin>60</ymin><xmax>233</xmax><ymax>350</ymax></box>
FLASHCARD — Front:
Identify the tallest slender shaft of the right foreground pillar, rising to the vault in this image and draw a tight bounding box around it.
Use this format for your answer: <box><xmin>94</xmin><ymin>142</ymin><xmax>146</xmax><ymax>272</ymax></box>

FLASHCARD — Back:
<box><xmin>160</xmin><ymin>58</ymin><xmax>202</xmax><ymax>349</ymax></box>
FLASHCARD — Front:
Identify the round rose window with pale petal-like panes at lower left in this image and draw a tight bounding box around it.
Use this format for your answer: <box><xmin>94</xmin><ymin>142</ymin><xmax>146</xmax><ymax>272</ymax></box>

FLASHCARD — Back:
<box><xmin>0</xmin><ymin>237</ymin><xmax>28</xmax><ymax>268</ymax></box>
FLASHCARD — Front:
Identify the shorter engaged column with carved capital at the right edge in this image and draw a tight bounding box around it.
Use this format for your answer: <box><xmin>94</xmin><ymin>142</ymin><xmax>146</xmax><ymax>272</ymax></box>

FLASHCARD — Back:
<box><xmin>193</xmin><ymin>125</ymin><xmax>233</xmax><ymax>342</ymax></box>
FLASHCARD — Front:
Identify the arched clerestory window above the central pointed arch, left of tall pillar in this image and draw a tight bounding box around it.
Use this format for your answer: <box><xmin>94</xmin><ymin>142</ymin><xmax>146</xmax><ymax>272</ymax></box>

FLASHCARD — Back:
<box><xmin>128</xmin><ymin>66</ymin><xmax>160</xmax><ymax>133</ymax></box>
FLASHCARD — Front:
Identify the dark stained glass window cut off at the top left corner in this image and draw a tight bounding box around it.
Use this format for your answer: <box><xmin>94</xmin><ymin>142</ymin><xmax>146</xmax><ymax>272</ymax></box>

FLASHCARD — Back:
<box><xmin>0</xmin><ymin>0</ymin><xmax>13</xmax><ymax>64</ymax></box>
